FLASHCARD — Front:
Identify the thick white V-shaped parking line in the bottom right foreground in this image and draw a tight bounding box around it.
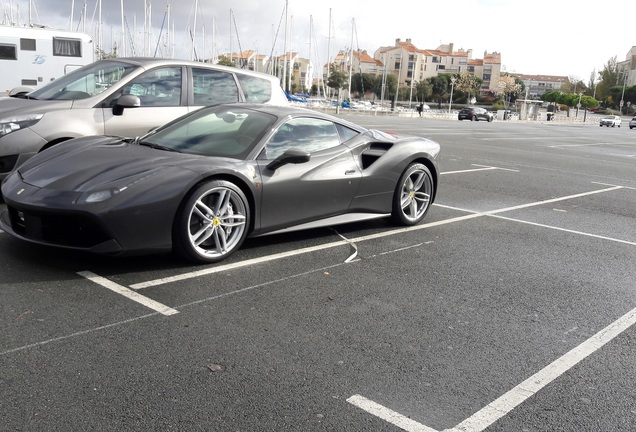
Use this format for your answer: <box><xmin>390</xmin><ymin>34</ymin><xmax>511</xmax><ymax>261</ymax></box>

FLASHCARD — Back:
<box><xmin>347</xmin><ymin>302</ymin><xmax>636</xmax><ymax>432</ymax></box>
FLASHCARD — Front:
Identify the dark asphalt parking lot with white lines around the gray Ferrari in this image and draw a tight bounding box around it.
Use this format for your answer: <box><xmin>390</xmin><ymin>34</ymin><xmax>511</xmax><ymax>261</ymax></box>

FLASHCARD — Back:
<box><xmin>0</xmin><ymin>117</ymin><xmax>636</xmax><ymax>432</ymax></box>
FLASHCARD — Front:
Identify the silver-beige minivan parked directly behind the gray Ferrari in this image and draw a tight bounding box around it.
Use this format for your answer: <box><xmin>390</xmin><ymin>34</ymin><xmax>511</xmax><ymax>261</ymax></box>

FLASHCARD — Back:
<box><xmin>0</xmin><ymin>58</ymin><xmax>288</xmax><ymax>180</ymax></box>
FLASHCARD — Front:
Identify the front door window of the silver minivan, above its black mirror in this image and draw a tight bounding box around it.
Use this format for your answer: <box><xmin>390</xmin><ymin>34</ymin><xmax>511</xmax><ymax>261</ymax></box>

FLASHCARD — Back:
<box><xmin>124</xmin><ymin>67</ymin><xmax>181</xmax><ymax>107</ymax></box>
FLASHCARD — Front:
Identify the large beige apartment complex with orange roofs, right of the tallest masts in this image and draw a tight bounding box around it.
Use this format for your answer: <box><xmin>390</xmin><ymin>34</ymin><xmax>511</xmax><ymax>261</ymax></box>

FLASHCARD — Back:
<box><xmin>373</xmin><ymin>39</ymin><xmax>501</xmax><ymax>94</ymax></box>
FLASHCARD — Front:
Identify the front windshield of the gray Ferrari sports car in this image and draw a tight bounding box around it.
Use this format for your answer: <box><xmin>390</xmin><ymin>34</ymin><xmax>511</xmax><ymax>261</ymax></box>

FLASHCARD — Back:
<box><xmin>139</xmin><ymin>106</ymin><xmax>276</xmax><ymax>159</ymax></box>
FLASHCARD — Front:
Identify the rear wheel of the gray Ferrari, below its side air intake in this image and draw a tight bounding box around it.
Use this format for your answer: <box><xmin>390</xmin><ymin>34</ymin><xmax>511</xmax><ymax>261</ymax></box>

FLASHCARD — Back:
<box><xmin>391</xmin><ymin>163</ymin><xmax>435</xmax><ymax>226</ymax></box>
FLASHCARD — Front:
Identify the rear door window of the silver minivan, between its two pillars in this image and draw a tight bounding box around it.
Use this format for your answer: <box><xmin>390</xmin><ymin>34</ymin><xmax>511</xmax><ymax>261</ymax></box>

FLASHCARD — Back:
<box><xmin>192</xmin><ymin>68</ymin><xmax>239</xmax><ymax>105</ymax></box>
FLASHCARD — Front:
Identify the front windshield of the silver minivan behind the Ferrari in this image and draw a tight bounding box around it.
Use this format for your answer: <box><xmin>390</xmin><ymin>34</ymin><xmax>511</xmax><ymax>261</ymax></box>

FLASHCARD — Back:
<box><xmin>29</xmin><ymin>61</ymin><xmax>139</xmax><ymax>100</ymax></box>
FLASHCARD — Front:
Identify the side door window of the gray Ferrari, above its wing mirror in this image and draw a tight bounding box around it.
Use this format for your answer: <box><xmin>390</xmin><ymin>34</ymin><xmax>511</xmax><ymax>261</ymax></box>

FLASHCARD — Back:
<box><xmin>265</xmin><ymin>118</ymin><xmax>340</xmax><ymax>159</ymax></box>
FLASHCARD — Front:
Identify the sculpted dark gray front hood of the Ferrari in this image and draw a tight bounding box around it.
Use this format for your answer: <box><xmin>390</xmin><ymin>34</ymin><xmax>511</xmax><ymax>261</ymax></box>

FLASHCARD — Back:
<box><xmin>18</xmin><ymin>137</ymin><xmax>210</xmax><ymax>192</ymax></box>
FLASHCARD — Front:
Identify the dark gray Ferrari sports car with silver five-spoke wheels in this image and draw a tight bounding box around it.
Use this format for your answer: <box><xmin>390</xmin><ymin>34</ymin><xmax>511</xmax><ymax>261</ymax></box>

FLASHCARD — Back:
<box><xmin>0</xmin><ymin>104</ymin><xmax>440</xmax><ymax>263</ymax></box>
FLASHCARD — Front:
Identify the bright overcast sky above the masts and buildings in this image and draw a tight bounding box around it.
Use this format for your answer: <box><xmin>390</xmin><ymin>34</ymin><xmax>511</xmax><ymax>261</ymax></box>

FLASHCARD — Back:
<box><xmin>0</xmin><ymin>0</ymin><xmax>636</xmax><ymax>83</ymax></box>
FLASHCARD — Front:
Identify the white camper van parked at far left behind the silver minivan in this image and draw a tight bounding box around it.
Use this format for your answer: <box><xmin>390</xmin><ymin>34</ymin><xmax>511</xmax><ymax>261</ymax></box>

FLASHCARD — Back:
<box><xmin>0</xmin><ymin>26</ymin><xmax>95</xmax><ymax>96</ymax></box>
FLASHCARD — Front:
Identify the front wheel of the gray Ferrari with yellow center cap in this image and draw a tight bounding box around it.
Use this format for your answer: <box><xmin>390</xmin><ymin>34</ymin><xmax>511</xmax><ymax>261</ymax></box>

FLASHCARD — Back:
<box><xmin>173</xmin><ymin>180</ymin><xmax>250</xmax><ymax>263</ymax></box>
